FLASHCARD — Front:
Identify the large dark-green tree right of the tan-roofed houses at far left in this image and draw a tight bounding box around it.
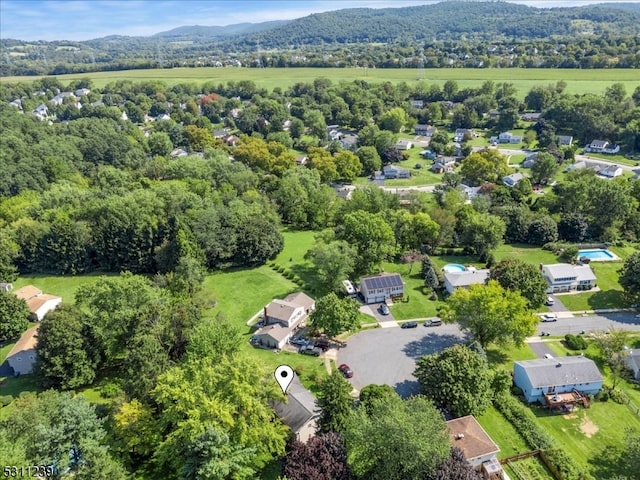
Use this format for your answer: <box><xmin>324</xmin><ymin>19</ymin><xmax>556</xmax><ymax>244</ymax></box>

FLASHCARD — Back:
<box><xmin>34</xmin><ymin>305</ymin><xmax>102</xmax><ymax>390</ymax></box>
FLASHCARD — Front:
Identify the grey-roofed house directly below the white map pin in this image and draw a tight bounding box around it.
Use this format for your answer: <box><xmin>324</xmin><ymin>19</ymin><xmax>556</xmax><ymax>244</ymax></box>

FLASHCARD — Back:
<box><xmin>273</xmin><ymin>375</ymin><xmax>320</xmax><ymax>443</ymax></box>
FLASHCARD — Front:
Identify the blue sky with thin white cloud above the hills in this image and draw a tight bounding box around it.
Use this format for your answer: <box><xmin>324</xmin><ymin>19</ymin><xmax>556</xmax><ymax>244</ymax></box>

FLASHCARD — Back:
<box><xmin>0</xmin><ymin>0</ymin><xmax>637</xmax><ymax>40</ymax></box>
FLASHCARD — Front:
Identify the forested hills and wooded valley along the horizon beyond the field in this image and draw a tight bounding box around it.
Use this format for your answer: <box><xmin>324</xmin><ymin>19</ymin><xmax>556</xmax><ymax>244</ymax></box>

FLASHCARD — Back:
<box><xmin>0</xmin><ymin>2</ymin><xmax>640</xmax><ymax>76</ymax></box>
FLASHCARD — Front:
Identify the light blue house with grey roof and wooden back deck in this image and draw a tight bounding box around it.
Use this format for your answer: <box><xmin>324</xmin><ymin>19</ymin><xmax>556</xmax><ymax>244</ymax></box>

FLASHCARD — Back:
<box><xmin>513</xmin><ymin>356</ymin><xmax>602</xmax><ymax>403</ymax></box>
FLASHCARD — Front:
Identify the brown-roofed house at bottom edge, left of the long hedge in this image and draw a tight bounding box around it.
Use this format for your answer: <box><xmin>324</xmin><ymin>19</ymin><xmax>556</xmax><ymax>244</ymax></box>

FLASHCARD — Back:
<box><xmin>447</xmin><ymin>415</ymin><xmax>503</xmax><ymax>480</ymax></box>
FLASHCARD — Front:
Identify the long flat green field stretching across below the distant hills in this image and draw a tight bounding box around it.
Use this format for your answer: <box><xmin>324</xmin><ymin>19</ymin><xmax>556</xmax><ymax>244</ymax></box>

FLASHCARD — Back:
<box><xmin>0</xmin><ymin>67</ymin><xmax>640</xmax><ymax>98</ymax></box>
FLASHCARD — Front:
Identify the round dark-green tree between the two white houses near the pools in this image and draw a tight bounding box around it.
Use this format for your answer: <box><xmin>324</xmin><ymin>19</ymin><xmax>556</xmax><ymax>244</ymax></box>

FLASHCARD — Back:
<box><xmin>490</xmin><ymin>258</ymin><xmax>549</xmax><ymax>310</ymax></box>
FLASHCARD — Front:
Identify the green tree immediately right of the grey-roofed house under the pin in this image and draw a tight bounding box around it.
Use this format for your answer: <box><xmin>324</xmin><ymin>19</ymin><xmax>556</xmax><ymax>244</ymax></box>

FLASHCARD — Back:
<box><xmin>317</xmin><ymin>370</ymin><xmax>353</xmax><ymax>433</ymax></box>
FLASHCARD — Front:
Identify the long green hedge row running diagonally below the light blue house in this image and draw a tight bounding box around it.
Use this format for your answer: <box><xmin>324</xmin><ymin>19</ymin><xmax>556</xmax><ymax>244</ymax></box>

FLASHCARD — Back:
<box><xmin>495</xmin><ymin>394</ymin><xmax>593</xmax><ymax>480</ymax></box>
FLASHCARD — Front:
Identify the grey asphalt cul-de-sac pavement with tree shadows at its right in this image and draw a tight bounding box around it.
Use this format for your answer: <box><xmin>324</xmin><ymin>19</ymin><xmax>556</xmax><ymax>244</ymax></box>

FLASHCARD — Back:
<box><xmin>337</xmin><ymin>324</ymin><xmax>465</xmax><ymax>398</ymax></box>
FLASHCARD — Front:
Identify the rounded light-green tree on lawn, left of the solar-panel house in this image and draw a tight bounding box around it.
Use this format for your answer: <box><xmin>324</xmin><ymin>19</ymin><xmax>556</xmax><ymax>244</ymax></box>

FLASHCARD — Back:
<box><xmin>304</xmin><ymin>237</ymin><xmax>356</xmax><ymax>291</ymax></box>
